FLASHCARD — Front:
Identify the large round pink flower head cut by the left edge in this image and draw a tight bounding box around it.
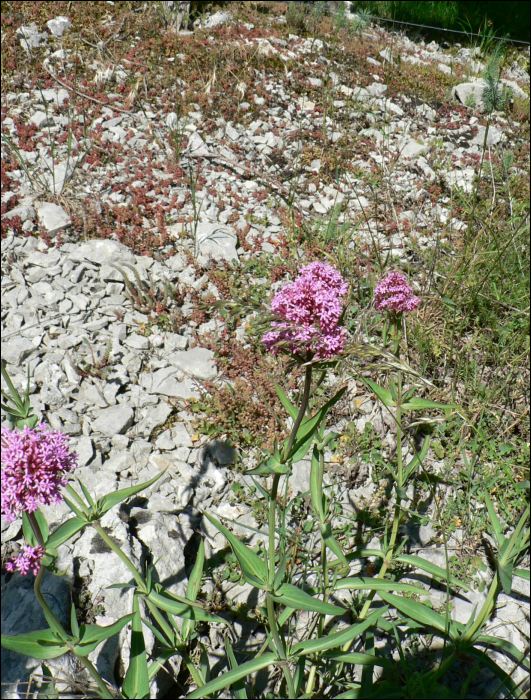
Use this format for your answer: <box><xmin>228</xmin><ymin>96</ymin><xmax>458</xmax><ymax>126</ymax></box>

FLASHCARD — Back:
<box><xmin>2</xmin><ymin>423</ymin><xmax>77</xmax><ymax>522</ymax></box>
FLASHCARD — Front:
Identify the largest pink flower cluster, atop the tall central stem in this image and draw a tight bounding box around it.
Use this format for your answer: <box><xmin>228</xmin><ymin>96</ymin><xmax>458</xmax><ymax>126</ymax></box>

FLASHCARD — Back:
<box><xmin>262</xmin><ymin>262</ymin><xmax>348</xmax><ymax>359</ymax></box>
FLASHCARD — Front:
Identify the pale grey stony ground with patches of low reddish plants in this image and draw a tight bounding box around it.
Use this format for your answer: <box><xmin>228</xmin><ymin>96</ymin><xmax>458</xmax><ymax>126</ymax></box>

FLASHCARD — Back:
<box><xmin>1</xmin><ymin>2</ymin><xmax>529</xmax><ymax>697</ymax></box>
